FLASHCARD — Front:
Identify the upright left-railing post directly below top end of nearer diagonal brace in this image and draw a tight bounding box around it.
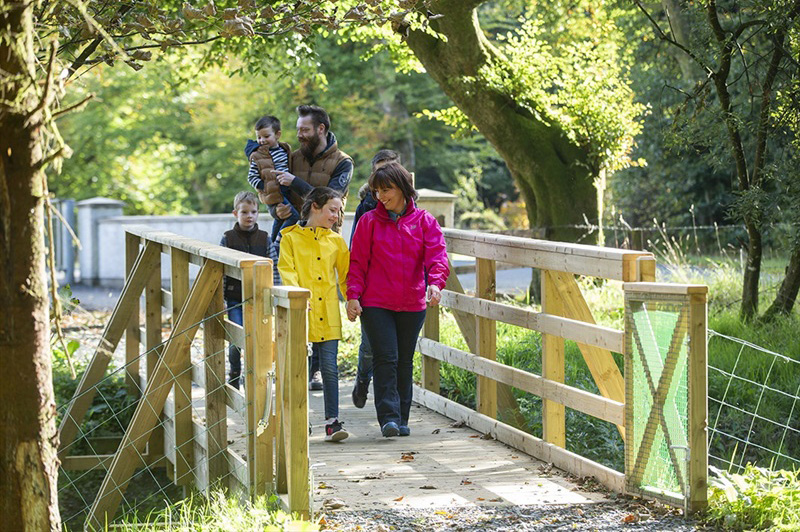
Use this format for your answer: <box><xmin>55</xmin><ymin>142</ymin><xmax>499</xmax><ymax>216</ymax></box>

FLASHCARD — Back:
<box><xmin>203</xmin><ymin>284</ymin><xmax>229</xmax><ymax>486</ymax></box>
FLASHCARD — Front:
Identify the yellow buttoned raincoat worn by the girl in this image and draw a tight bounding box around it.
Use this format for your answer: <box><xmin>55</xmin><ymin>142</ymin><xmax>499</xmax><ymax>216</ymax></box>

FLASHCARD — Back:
<box><xmin>278</xmin><ymin>224</ymin><xmax>350</xmax><ymax>342</ymax></box>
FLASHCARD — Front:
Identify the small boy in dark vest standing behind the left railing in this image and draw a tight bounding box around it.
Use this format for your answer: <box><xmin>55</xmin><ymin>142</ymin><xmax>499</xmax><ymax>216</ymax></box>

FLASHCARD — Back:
<box><xmin>219</xmin><ymin>191</ymin><xmax>281</xmax><ymax>388</ymax></box>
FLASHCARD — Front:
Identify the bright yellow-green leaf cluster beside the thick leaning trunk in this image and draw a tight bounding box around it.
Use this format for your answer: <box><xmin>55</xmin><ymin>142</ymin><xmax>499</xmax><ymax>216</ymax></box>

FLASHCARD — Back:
<box><xmin>478</xmin><ymin>5</ymin><xmax>646</xmax><ymax>175</ymax></box>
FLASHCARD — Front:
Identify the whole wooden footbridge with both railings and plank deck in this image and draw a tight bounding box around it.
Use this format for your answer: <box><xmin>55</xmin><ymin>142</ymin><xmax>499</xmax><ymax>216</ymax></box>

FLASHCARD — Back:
<box><xmin>59</xmin><ymin>227</ymin><xmax>707</xmax><ymax>529</ymax></box>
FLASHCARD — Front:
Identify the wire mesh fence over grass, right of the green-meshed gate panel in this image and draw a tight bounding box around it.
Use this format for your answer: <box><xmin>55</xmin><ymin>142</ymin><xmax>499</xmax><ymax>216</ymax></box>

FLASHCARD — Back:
<box><xmin>708</xmin><ymin>330</ymin><xmax>800</xmax><ymax>473</ymax></box>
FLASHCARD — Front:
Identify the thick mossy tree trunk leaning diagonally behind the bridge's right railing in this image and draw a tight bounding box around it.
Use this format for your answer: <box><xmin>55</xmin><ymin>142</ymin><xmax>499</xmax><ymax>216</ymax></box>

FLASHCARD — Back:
<box><xmin>398</xmin><ymin>0</ymin><xmax>598</xmax><ymax>241</ymax></box>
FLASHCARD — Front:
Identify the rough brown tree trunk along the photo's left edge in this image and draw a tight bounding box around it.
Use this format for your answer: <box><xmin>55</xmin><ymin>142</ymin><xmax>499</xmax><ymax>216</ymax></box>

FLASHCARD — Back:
<box><xmin>0</xmin><ymin>2</ymin><xmax>61</xmax><ymax>532</ymax></box>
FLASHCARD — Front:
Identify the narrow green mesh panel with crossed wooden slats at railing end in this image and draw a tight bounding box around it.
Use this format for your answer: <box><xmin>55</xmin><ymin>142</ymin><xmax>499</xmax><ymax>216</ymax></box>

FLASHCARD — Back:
<box><xmin>625</xmin><ymin>293</ymin><xmax>689</xmax><ymax>505</ymax></box>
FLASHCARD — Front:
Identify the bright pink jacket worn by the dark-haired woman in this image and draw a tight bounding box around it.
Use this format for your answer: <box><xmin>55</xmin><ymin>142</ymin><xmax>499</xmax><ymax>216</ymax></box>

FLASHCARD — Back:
<box><xmin>347</xmin><ymin>201</ymin><xmax>450</xmax><ymax>312</ymax></box>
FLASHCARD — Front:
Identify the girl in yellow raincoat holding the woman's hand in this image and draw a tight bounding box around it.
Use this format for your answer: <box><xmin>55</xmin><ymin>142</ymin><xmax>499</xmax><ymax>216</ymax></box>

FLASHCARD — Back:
<box><xmin>278</xmin><ymin>187</ymin><xmax>350</xmax><ymax>441</ymax></box>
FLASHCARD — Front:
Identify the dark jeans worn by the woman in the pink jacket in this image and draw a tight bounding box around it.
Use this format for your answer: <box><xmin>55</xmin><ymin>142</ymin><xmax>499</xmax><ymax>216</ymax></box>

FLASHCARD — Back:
<box><xmin>361</xmin><ymin>307</ymin><xmax>425</xmax><ymax>427</ymax></box>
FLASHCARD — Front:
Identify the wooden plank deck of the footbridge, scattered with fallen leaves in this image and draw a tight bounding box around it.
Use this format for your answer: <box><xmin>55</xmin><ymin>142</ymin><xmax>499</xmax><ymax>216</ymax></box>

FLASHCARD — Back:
<box><xmin>309</xmin><ymin>382</ymin><xmax>604</xmax><ymax>511</ymax></box>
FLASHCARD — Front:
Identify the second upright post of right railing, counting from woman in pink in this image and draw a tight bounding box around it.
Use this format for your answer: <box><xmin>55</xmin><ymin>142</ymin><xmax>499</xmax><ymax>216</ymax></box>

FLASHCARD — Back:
<box><xmin>475</xmin><ymin>258</ymin><xmax>497</xmax><ymax>419</ymax></box>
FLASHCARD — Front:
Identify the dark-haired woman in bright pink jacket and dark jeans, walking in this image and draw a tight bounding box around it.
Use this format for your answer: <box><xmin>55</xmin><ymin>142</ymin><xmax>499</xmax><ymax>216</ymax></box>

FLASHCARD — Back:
<box><xmin>347</xmin><ymin>163</ymin><xmax>450</xmax><ymax>437</ymax></box>
